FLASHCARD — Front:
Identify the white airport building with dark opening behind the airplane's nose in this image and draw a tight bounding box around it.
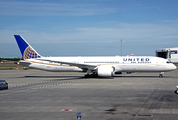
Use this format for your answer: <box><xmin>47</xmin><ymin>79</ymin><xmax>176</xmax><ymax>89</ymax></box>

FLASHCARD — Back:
<box><xmin>156</xmin><ymin>47</ymin><xmax>178</xmax><ymax>63</ymax></box>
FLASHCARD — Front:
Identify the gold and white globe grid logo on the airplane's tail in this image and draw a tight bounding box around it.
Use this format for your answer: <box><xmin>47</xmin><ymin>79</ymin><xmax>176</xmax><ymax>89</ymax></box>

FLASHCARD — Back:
<box><xmin>23</xmin><ymin>46</ymin><xmax>40</xmax><ymax>59</ymax></box>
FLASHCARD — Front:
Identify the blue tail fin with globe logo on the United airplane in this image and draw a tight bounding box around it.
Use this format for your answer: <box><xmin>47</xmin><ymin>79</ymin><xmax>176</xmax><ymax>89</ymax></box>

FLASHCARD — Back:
<box><xmin>14</xmin><ymin>35</ymin><xmax>41</xmax><ymax>59</ymax></box>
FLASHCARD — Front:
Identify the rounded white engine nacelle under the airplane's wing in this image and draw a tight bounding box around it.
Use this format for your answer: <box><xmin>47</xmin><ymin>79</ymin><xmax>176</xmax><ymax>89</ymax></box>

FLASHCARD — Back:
<box><xmin>97</xmin><ymin>65</ymin><xmax>115</xmax><ymax>77</ymax></box>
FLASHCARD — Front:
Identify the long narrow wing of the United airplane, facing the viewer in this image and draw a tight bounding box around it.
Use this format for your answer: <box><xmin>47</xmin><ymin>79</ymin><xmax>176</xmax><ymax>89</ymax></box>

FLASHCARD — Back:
<box><xmin>36</xmin><ymin>58</ymin><xmax>97</xmax><ymax>70</ymax></box>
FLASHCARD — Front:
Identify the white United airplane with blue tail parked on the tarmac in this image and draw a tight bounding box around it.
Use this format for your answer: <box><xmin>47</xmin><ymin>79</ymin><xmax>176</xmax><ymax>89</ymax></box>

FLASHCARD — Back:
<box><xmin>14</xmin><ymin>35</ymin><xmax>177</xmax><ymax>77</ymax></box>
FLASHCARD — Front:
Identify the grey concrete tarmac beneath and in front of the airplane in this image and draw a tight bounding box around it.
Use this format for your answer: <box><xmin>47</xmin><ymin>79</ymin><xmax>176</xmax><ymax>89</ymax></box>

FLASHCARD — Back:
<box><xmin>0</xmin><ymin>69</ymin><xmax>178</xmax><ymax>120</ymax></box>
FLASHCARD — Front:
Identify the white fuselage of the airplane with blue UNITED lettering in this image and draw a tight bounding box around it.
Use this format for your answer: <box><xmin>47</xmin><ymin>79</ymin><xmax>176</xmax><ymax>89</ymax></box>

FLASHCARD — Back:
<box><xmin>19</xmin><ymin>56</ymin><xmax>176</xmax><ymax>72</ymax></box>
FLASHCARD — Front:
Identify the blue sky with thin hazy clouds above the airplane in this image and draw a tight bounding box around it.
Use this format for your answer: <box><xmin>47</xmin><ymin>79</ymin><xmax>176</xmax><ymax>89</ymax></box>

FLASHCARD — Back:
<box><xmin>0</xmin><ymin>0</ymin><xmax>178</xmax><ymax>57</ymax></box>
